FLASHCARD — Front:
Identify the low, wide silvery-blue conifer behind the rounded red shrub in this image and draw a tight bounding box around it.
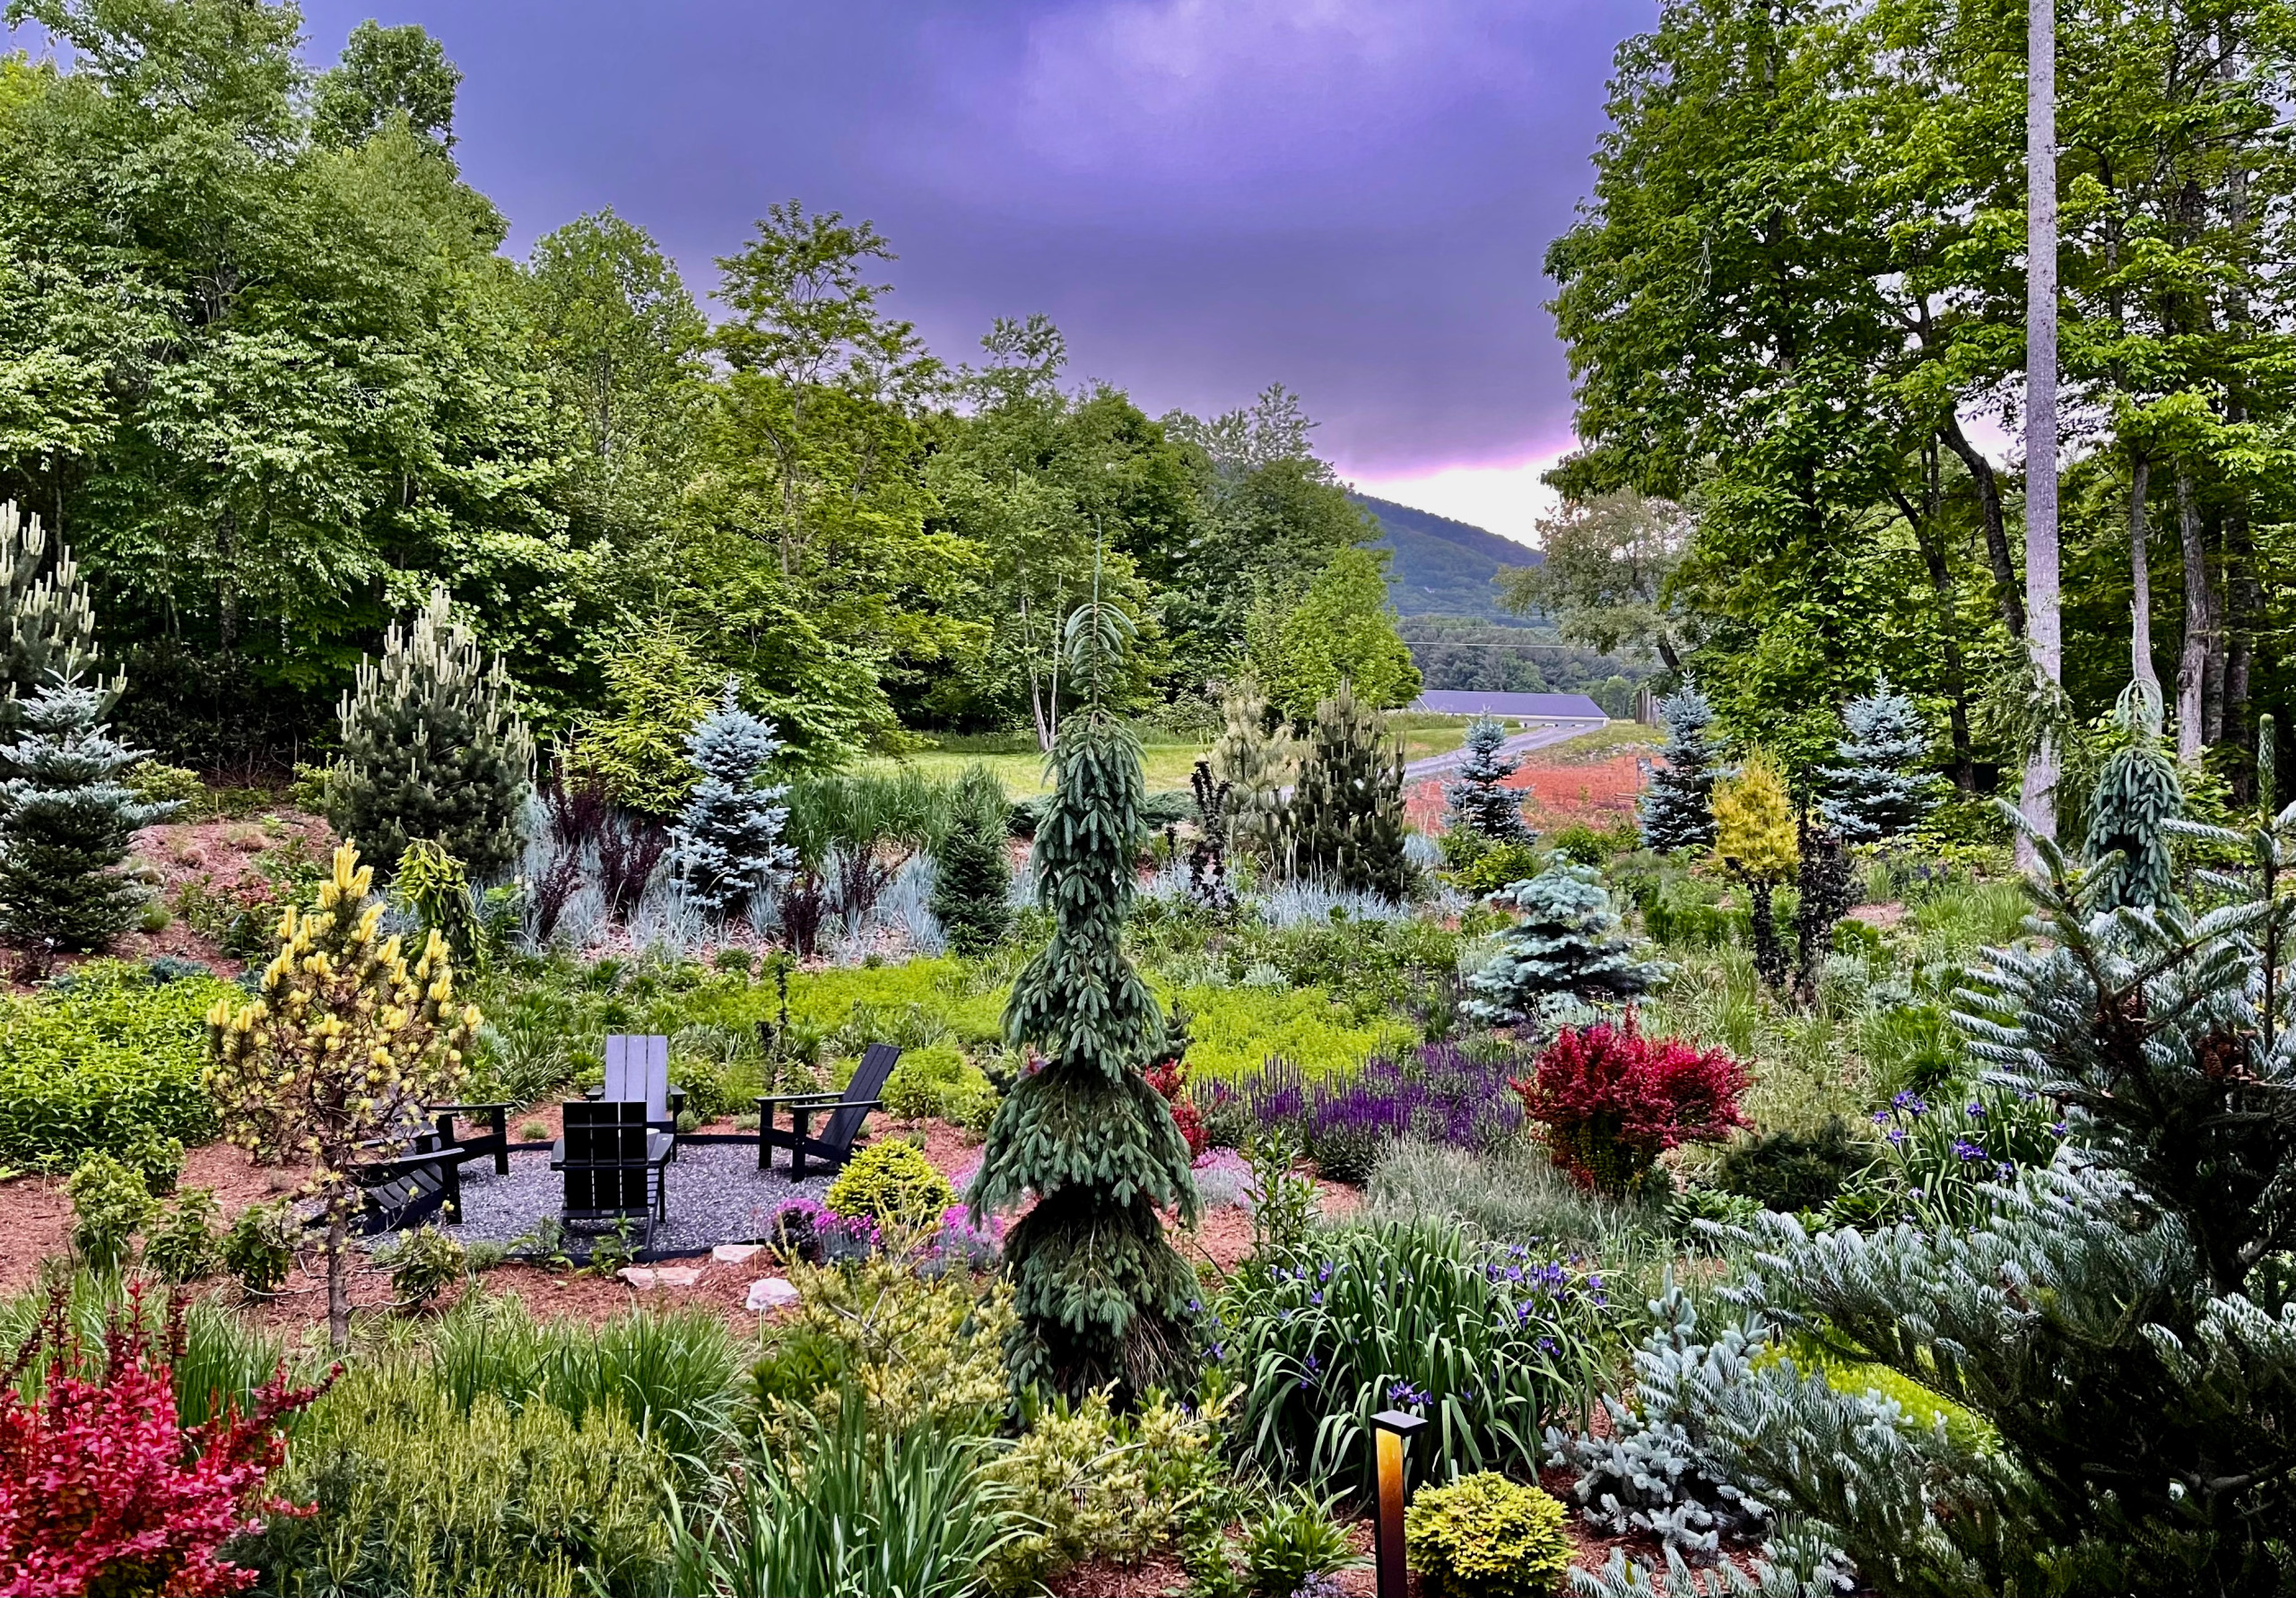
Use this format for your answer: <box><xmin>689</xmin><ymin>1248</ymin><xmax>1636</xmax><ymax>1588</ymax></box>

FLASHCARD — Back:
<box><xmin>1465</xmin><ymin>865</ymin><xmax>1665</xmax><ymax>1026</ymax></box>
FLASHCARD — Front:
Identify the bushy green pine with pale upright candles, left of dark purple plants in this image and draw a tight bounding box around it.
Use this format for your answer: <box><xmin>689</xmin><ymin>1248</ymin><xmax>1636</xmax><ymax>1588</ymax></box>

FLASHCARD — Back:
<box><xmin>326</xmin><ymin>587</ymin><xmax>535</xmax><ymax>882</ymax></box>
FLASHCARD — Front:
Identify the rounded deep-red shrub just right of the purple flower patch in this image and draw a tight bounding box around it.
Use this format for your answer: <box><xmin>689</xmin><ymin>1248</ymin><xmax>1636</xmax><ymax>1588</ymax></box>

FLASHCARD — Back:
<box><xmin>1513</xmin><ymin>1011</ymin><xmax>1747</xmax><ymax>1194</ymax></box>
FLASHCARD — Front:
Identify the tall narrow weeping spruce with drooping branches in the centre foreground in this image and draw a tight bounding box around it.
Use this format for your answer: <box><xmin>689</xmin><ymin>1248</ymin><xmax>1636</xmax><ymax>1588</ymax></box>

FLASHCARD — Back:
<box><xmin>969</xmin><ymin>574</ymin><xmax>1196</xmax><ymax>1398</ymax></box>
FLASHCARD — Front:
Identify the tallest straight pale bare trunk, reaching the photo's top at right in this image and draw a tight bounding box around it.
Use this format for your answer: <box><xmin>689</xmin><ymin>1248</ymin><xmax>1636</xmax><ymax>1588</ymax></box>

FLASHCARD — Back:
<box><xmin>2018</xmin><ymin>0</ymin><xmax>2064</xmax><ymax>856</ymax></box>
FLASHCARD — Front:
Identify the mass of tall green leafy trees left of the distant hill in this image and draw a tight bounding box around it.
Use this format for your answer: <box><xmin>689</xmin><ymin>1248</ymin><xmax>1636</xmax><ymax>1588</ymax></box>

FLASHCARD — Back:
<box><xmin>0</xmin><ymin>0</ymin><xmax>1419</xmax><ymax>781</ymax></box>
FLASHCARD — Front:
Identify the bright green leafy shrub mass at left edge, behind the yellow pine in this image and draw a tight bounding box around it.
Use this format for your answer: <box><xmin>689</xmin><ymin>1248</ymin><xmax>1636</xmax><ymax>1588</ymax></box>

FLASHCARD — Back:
<box><xmin>0</xmin><ymin>960</ymin><xmax>239</xmax><ymax>1168</ymax></box>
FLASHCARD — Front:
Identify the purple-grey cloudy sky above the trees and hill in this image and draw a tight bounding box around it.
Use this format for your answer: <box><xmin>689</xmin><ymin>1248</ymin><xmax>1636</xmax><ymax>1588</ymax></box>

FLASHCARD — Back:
<box><xmin>36</xmin><ymin>0</ymin><xmax>1656</xmax><ymax>537</ymax></box>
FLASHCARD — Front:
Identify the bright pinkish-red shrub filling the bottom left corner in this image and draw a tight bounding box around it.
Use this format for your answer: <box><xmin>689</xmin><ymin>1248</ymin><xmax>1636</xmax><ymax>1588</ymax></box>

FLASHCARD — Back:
<box><xmin>0</xmin><ymin>1283</ymin><xmax>319</xmax><ymax>1598</ymax></box>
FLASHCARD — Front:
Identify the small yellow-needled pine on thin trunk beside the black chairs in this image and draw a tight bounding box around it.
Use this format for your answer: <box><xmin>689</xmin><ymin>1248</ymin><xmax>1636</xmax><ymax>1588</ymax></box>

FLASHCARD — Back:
<box><xmin>206</xmin><ymin>843</ymin><xmax>480</xmax><ymax>1348</ymax></box>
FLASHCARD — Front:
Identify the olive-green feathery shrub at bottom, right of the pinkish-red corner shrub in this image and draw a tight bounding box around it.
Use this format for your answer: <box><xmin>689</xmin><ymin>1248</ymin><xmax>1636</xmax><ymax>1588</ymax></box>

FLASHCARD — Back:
<box><xmin>239</xmin><ymin>1359</ymin><xmax>671</xmax><ymax>1598</ymax></box>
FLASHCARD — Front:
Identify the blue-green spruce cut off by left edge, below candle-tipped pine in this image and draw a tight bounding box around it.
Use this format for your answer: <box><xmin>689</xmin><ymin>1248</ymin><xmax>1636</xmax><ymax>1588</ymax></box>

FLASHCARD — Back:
<box><xmin>0</xmin><ymin>673</ymin><xmax>177</xmax><ymax>951</ymax></box>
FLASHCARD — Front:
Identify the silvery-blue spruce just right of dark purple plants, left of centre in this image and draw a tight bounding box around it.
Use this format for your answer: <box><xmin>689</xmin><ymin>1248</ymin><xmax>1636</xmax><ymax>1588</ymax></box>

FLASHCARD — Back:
<box><xmin>671</xmin><ymin>677</ymin><xmax>795</xmax><ymax>918</ymax></box>
